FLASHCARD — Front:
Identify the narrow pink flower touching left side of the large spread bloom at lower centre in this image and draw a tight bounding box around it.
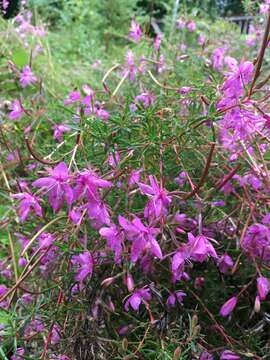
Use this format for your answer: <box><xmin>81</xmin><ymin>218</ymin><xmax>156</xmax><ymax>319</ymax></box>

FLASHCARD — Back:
<box><xmin>99</xmin><ymin>224</ymin><xmax>125</xmax><ymax>263</ymax></box>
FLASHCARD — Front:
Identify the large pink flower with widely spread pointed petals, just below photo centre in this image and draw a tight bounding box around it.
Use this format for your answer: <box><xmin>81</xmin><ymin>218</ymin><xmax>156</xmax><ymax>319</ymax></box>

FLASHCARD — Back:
<box><xmin>118</xmin><ymin>216</ymin><xmax>162</xmax><ymax>262</ymax></box>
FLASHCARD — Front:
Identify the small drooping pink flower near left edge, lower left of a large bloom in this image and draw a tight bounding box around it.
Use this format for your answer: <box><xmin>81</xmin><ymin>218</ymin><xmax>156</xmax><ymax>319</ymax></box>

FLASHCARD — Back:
<box><xmin>12</xmin><ymin>192</ymin><xmax>42</xmax><ymax>222</ymax></box>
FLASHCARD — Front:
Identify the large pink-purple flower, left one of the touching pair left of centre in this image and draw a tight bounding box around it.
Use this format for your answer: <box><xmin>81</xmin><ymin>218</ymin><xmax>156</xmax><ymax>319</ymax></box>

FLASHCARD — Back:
<box><xmin>32</xmin><ymin>162</ymin><xmax>73</xmax><ymax>212</ymax></box>
